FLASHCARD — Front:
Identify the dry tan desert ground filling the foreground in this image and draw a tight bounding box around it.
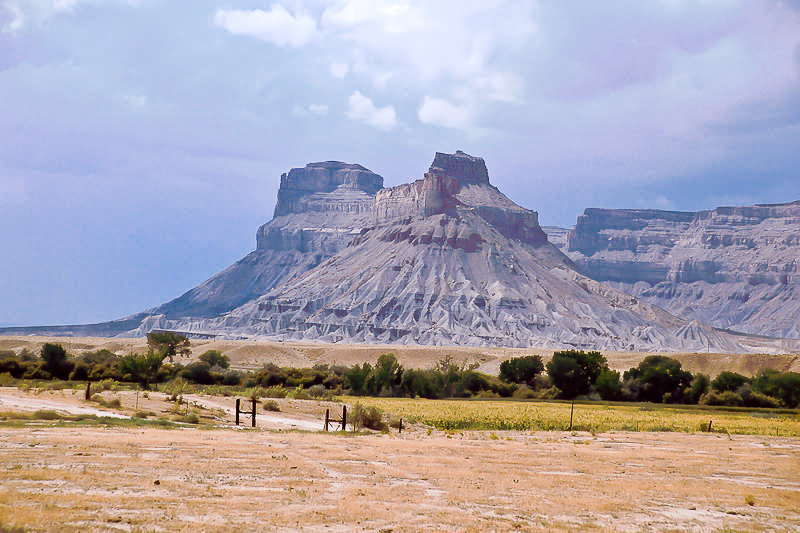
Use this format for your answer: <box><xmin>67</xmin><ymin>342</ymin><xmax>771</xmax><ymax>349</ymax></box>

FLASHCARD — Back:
<box><xmin>0</xmin><ymin>387</ymin><xmax>800</xmax><ymax>532</ymax></box>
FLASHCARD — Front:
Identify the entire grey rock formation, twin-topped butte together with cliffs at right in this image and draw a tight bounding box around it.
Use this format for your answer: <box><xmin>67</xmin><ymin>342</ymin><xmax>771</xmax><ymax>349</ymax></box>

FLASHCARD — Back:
<box><xmin>6</xmin><ymin>151</ymin><xmax>800</xmax><ymax>352</ymax></box>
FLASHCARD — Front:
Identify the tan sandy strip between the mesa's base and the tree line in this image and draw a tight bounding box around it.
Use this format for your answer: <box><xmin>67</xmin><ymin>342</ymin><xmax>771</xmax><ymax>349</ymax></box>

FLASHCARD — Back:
<box><xmin>0</xmin><ymin>336</ymin><xmax>800</xmax><ymax>376</ymax></box>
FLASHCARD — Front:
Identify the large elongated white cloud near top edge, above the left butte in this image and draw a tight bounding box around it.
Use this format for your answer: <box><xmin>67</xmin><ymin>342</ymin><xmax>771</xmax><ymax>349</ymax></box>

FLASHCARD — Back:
<box><xmin>214</xmin><ymin>4</ymin><xmax>317</xmax><ymax>48</ymax></box>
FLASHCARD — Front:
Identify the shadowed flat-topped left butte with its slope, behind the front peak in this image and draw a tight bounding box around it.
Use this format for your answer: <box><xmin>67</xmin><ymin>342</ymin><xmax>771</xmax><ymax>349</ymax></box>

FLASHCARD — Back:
<box><xmin>154</xmin><ymin>161</ymin><xmax>383</xmax><ymax>319</ymax></box>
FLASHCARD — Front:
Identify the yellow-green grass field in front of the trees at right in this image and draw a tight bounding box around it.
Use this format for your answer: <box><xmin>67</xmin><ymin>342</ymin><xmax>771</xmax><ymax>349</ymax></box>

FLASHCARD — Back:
<box><xmin>350</xmin><ymin>398</ymin><xmax>800</xmax><ymax>437</ymax></box>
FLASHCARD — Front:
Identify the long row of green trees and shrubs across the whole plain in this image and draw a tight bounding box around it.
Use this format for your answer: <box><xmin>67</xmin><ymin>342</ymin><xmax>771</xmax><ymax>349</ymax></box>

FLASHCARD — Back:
<box><xmin>0</xmin><ymin>340</ymin><xmax>800</xmax><ymax>408</ymax></box>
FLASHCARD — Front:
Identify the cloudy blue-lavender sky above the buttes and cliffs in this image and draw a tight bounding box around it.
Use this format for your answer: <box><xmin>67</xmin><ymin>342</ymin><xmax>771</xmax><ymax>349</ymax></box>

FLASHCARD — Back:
<box><xmin>0</xmin><ymin>0</ymin><xmax>800</xmax><ymax>325</ymax></box>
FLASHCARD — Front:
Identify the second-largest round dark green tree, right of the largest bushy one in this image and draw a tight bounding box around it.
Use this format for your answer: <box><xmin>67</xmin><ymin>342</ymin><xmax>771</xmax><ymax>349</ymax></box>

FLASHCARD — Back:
<box><xmin>625</xmin><ymin>355</ymin><xmax>692</xmax><ymax>403</ymax></box>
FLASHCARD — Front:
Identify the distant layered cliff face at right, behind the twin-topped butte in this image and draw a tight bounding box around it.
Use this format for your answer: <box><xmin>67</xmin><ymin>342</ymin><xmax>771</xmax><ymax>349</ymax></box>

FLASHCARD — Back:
<box><xmin>564</xmin><ymin>202</ymin><xmax>800</xmax><ymax>338</ymax></box>
